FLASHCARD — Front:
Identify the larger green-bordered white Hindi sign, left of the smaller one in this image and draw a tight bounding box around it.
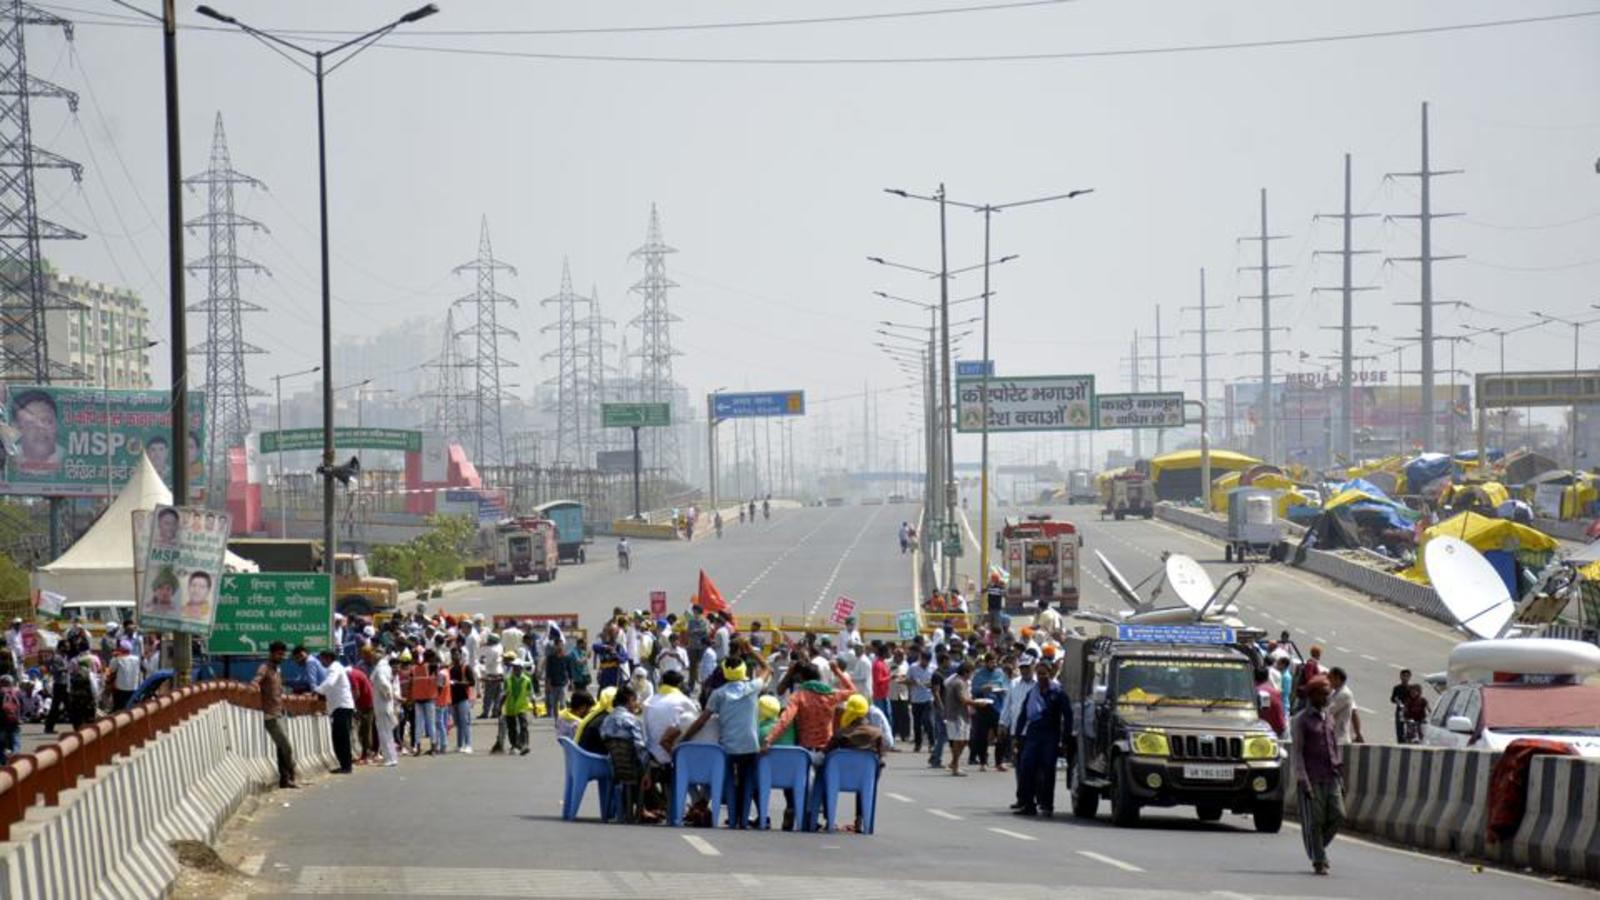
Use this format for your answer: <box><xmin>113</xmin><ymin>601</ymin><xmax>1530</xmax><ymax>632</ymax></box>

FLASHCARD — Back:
<box><xmin>955</xmin><ymin>375</ymin><xmax>1094</xmax><ymax>434</ymax></box>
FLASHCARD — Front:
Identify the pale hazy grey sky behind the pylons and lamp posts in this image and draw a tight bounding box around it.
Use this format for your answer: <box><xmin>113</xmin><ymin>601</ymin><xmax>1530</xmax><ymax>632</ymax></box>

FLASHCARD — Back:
<box><xmin>29</xmin><ymin>0</ymin><xmax>1600</xmax><ymax>458</ymax></box>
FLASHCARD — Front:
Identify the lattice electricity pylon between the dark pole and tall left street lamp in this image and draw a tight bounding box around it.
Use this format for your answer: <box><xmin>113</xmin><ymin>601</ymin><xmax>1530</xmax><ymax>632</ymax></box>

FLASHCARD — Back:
<box><xmin>184</xmin><ymin>112</ymin><xmax>266</xmax><ymax>500</ymax></box>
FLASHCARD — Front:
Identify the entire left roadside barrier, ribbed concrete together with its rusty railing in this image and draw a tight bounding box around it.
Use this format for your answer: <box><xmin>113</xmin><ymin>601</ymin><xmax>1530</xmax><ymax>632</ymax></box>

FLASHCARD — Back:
<box><xmin>0</xmin><ymin>682</ymin><xmax>336</xmax><ymax>900</ymax></box>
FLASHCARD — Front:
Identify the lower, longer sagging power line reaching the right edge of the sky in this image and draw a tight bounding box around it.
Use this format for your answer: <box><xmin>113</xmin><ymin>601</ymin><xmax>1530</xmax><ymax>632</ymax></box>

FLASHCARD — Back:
<box><xmin>50</xmin><ymin>10</ymin><xmax>1600</xmax><ymax>66</ymax></box>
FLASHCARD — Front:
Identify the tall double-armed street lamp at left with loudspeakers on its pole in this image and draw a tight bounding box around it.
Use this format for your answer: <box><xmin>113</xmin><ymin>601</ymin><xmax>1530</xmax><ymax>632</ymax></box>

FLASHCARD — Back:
<box><xmin>195</xmin><ymin>3</ymin><xmax>438</xmax><ymax>573</ymax></box>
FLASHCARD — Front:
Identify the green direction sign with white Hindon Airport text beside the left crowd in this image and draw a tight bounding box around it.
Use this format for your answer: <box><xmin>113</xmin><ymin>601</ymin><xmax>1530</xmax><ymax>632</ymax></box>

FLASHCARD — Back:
<box><xmin>206</xmin><ymin>572</ymin><xmax>333</xmax><ymax>657</ymax></box>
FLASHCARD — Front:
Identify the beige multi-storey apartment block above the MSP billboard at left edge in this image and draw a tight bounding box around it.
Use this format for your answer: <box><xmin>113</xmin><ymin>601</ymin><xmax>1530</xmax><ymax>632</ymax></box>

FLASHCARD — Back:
<box><xmin>45</xmin><ymin>259</ymin><xmax>152</xmax><ymax>389</ymax></box>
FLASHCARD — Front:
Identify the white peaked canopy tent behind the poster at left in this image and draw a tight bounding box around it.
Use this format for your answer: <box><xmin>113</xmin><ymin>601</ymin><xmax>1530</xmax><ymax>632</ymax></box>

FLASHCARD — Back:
<box><xmin>34</xmin><ymin>455</ymin><xmax>258</xmax><ymax>601</ymax></box>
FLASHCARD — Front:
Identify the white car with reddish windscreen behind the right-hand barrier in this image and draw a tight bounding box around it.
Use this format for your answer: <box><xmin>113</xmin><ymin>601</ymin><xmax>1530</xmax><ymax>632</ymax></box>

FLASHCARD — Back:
<box><xmin>1422</xmin><ymin>682</ymin><xmax>1600</xmax><ymax>759</ymax></box>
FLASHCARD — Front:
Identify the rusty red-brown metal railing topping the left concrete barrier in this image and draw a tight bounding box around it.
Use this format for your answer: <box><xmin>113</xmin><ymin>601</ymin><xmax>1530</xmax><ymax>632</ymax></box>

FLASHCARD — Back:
<box><xmin>0</xmin><ymin>681</ymin><xmax>323</xmax><ymax>841</ymax></box>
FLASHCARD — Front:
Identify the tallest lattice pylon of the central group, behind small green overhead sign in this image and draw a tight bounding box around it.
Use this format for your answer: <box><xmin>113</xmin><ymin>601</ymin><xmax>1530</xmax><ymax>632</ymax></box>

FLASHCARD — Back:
<box><xmin>629</xmin><ymin>203</ymin><xmax>686</xmax><ymax>474</ymax></box>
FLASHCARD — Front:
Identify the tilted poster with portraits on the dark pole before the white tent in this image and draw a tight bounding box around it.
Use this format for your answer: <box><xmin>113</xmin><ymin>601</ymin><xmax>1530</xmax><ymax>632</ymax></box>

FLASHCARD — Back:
<box><xmin>138</xmin><ymin>506</ymin><xmax>230</xmax><ymax>634</ymax></box>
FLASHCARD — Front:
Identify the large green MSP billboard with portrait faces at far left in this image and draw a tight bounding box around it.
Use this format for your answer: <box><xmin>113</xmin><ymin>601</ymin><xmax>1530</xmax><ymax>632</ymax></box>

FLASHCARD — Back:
<box><xmin>0</xmin><ymin>384</ymin><xmax>206</xmax><ymax>496</ymax></box>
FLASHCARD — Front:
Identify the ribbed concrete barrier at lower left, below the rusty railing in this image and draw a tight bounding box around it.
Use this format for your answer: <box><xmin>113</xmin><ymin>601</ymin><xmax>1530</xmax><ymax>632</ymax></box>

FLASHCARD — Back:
<box><xmin>0</xmin><ymin>701</ymin><xmax>334</xmax><ymax>900</ymax></box>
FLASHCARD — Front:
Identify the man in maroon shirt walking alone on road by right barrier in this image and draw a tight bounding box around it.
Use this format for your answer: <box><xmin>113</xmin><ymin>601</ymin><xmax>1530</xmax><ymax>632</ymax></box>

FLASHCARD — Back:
<box><xmin>1290</xmin><ymin>676</ymin><xmax>1344</xmax><ymax>874</ymax></box>
